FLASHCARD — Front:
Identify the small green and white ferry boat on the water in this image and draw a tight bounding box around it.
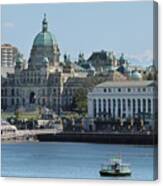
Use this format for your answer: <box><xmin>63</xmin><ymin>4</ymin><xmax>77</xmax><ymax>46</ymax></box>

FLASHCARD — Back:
<box><xmin>100</xmin><ymin>158</ymin><xmax>131</xmax><ymax>176</ymax></box>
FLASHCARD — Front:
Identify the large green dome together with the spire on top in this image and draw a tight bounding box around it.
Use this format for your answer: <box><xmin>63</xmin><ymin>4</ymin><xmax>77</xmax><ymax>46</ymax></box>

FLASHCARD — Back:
<box><xmin>33</xmin><ymin>14</ymin><xmax>57</xmax><ymax>46</ymax></box>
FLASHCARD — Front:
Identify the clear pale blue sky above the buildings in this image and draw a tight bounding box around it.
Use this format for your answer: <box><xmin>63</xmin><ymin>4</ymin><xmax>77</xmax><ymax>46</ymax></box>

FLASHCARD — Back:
<box><xmin>1</xmin><ymin>1</ymin><xmax>153</xmax><ymax>63</ymax></box>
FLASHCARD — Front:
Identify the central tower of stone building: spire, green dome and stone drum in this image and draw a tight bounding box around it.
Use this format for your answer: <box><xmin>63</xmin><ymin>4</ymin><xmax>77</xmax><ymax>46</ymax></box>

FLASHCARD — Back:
<box><xmin>28</xmin><ymin>14</ymin><xmax>60</xmax><ymax>68</ymax></box>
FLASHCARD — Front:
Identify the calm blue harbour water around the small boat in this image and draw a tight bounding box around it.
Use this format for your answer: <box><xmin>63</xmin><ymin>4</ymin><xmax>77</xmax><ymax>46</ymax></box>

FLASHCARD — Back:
<box><xmin>1</xmin><ymin>142</ymin><xmax>157</xmax><ymax>180</ymax></box>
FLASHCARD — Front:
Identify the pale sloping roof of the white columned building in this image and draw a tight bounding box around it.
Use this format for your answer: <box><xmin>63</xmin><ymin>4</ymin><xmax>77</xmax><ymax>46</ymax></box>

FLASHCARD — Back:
<box><xmin>96</xmin><ymin>81</ymin><xmax>154</xmax><ymax>88</ymax></box>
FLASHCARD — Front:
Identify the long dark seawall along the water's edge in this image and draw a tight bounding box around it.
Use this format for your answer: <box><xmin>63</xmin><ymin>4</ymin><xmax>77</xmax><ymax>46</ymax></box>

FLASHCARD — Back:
<box><xmin>36</xmin><ymin>132</ymin><xmax>158</xmax><ymax>145</ymax></box>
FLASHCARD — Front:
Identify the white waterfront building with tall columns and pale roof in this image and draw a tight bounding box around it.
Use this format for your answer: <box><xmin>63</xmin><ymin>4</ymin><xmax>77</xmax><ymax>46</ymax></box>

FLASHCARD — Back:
<box><xmin>88</xmin><ymin>80</ymin><xmax>156</xmax><ymax>119</ymax></box>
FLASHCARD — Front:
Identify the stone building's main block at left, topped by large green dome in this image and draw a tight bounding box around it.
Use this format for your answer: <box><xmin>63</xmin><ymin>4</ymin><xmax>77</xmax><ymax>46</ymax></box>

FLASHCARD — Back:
<box><xmin>1</xmin><ymin>15</ymin><xmax>63</xmax><ymax>113</ymax></box>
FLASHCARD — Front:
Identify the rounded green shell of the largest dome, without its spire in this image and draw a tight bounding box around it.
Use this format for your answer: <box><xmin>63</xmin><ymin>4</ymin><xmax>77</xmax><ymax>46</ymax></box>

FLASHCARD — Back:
<box><xmin>33</xmin><ymin>31</ymin><xmax>57</xmax><ymax>46</ymax></box>
